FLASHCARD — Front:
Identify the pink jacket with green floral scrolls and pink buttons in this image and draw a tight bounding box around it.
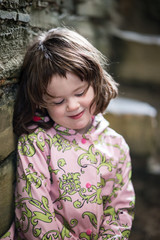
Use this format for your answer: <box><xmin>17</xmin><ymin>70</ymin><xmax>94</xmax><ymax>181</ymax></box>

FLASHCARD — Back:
<box><xmin>2</xmin><ymin>114</ymin><xmax>135</xmax><ymax>240</ymax></box>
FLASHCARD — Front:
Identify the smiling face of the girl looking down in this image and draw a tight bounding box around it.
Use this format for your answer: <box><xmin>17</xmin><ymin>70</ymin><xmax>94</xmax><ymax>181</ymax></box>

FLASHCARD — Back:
<box><xmin>44</xmin><ymin>72</ymin><xmax>95</xmax><ymax>133</ymax></box>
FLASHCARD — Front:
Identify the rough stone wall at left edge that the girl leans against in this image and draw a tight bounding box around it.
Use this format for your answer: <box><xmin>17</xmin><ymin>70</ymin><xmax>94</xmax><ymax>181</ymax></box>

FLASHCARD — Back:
<box><xmin>0</xmin><ymin>1</ymin><xmax>30</xmax><ymax>235</ymax></box>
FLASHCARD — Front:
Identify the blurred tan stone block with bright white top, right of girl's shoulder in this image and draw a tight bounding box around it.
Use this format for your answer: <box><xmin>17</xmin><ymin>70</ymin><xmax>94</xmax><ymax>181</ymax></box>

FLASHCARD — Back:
<box><xmin>104</xmin><ymin>98</ymin><xmax>157</xmax><ymax>156</ymax></box>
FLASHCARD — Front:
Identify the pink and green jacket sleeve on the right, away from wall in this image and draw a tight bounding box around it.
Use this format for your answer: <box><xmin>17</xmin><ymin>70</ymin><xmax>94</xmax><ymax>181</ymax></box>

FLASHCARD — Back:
<box><xmin>99</xmin><ymin>139</ymin><xmax>135</xmax><ymax>240</ymax></box>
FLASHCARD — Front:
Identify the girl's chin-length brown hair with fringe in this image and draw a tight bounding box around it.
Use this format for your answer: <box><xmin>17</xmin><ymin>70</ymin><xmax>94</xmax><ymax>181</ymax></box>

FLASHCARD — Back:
<box><xmin>13</xmin><ymin>28</ymin><xmax>117</xmax><ymax>135</ymax></box>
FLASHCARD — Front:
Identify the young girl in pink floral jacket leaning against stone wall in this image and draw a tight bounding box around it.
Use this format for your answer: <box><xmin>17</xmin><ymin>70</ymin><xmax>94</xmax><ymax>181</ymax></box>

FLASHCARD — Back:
<box><xmin>0</xmin><ymin>28</ymin><xmax>134</xmax><ymax>240</ymax></box>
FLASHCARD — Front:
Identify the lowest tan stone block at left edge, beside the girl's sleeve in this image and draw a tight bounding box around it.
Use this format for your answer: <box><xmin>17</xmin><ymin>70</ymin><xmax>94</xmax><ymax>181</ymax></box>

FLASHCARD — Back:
<box><xmin>0</xmin><ymin>153</ymin><xmax>15</xmax><ymax>236</ymax></box>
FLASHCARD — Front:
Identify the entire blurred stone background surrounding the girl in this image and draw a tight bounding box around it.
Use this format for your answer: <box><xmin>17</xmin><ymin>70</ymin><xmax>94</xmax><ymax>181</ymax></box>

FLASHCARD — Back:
<box><xmin>0</xmin><ymin>0</ymin><xmax>160</xmax><ymax>240</ymax></box>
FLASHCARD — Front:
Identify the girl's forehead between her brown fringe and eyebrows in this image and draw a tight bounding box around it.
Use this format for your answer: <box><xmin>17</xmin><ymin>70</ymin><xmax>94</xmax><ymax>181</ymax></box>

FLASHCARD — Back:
<box><xmin>47</xmin><ymin>73</ymin><xmax>88</xmax><ymax>97</ymax></box>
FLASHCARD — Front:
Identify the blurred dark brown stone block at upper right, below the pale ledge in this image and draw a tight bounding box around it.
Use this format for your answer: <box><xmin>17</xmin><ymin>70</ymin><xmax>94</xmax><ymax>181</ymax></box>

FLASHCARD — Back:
<box><xmin>113</xmin><ymin>37</ymin><xmax>160</xmax><ymax>86</ymax></box>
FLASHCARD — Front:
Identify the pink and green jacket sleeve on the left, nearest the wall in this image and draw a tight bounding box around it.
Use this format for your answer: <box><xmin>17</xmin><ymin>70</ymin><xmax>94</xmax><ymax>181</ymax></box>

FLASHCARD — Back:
<box><xmin>15</xmin><ymin>129</ymin><xmax>74</xmax><ymax>240</ymax></box>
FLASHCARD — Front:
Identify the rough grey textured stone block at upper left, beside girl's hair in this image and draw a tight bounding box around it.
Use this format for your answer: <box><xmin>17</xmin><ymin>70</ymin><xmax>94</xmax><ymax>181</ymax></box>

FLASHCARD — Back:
<box><xmin>0</xmin><ymin>24</ymin><xmax>29</xmax><ymax>79</ymax></box>
